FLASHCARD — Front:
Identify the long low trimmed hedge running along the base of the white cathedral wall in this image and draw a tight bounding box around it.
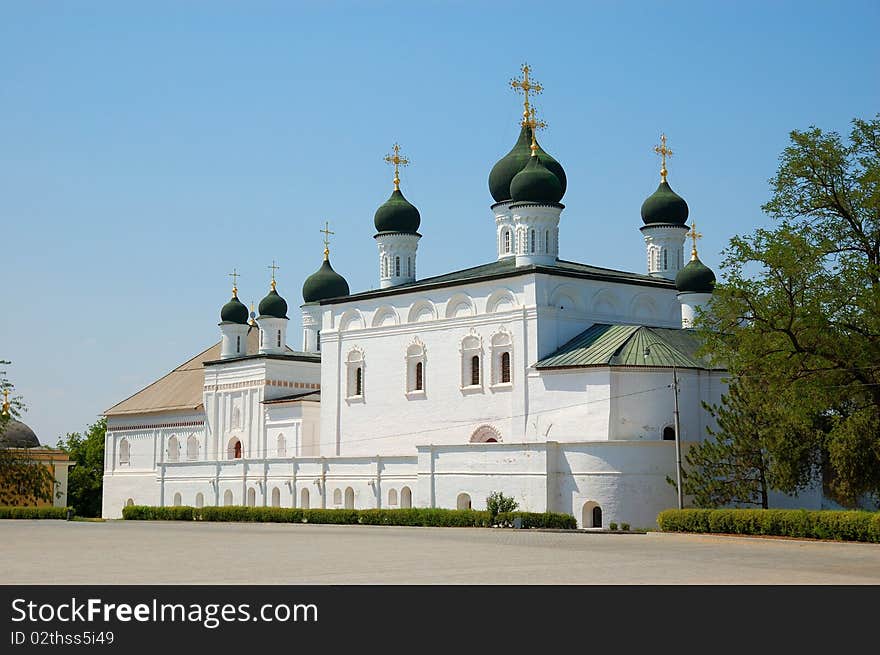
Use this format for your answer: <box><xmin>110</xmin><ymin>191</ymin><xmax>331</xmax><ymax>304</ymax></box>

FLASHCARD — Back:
<box><xmin>122</xmin><ymin>505</ymin><xmax>577</xmax><ymax>530</ymax></box>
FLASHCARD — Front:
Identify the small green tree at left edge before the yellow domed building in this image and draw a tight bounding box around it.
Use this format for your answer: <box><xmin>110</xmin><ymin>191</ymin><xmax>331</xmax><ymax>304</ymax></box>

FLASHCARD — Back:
<box><xmin>0</xmin><ymin>360</ymin><xmax>55</xmax><ymax>505</ymax></box>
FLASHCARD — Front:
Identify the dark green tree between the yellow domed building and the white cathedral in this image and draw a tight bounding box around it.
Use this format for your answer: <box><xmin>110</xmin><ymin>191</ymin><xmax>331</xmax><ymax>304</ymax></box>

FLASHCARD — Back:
<box><xmin>58</xmin><ymin>418</ymin><xmax>107</xmax><ymax>516</ymax></box>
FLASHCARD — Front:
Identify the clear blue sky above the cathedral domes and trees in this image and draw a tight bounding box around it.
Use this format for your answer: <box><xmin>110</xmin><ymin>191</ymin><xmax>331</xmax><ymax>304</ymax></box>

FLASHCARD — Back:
<box><xmin>0</xmin><ymin>0</ymin><xmax>880</xmax><ymax>444</ymax></box>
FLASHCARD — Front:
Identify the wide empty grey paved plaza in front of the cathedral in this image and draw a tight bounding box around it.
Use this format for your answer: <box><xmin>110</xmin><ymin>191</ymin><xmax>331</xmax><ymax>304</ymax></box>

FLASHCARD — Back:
<box><xmin>0</xmin><ymin>520</ymin><xmax>880</xmax><ymax>584</ymax></box>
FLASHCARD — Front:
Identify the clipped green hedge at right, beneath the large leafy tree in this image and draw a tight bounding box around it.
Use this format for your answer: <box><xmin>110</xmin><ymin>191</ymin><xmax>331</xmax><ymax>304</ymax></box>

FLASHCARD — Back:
<box><xmin>657</xmin><ymin>509</ymin><xmax>880</xmax><ymax>543</ymax></box>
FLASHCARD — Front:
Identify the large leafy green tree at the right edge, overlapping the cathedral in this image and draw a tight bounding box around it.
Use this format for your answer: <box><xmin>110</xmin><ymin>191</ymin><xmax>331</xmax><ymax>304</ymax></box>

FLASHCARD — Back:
<box><xmin>698</xmin><ymin>114</ymin><xmax>880</xmax><ymax>505</ymax></box>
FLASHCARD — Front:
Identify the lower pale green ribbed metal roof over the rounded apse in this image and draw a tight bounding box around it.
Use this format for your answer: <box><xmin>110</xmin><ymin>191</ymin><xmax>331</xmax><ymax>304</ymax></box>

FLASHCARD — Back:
<box><xmin>535</xmin><ymin>323</ymin><xmax>724</xmax><ymax>370</ymax></box>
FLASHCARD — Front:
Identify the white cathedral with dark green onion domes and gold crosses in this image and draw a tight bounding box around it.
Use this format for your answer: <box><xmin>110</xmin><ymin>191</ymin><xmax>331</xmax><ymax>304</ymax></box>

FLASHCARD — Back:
<box><xmin>103</xmin><ymin>67</ymin><xmax>808</xmax><ymax>528</ymax></box>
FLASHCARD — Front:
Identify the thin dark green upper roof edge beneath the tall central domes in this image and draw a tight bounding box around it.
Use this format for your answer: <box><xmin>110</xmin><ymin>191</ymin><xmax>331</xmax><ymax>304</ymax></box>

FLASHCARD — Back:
<box><xmin>319</xmin><ymin>257</ymin><xmax>675</xmax><ymax>305</ymax></box>
